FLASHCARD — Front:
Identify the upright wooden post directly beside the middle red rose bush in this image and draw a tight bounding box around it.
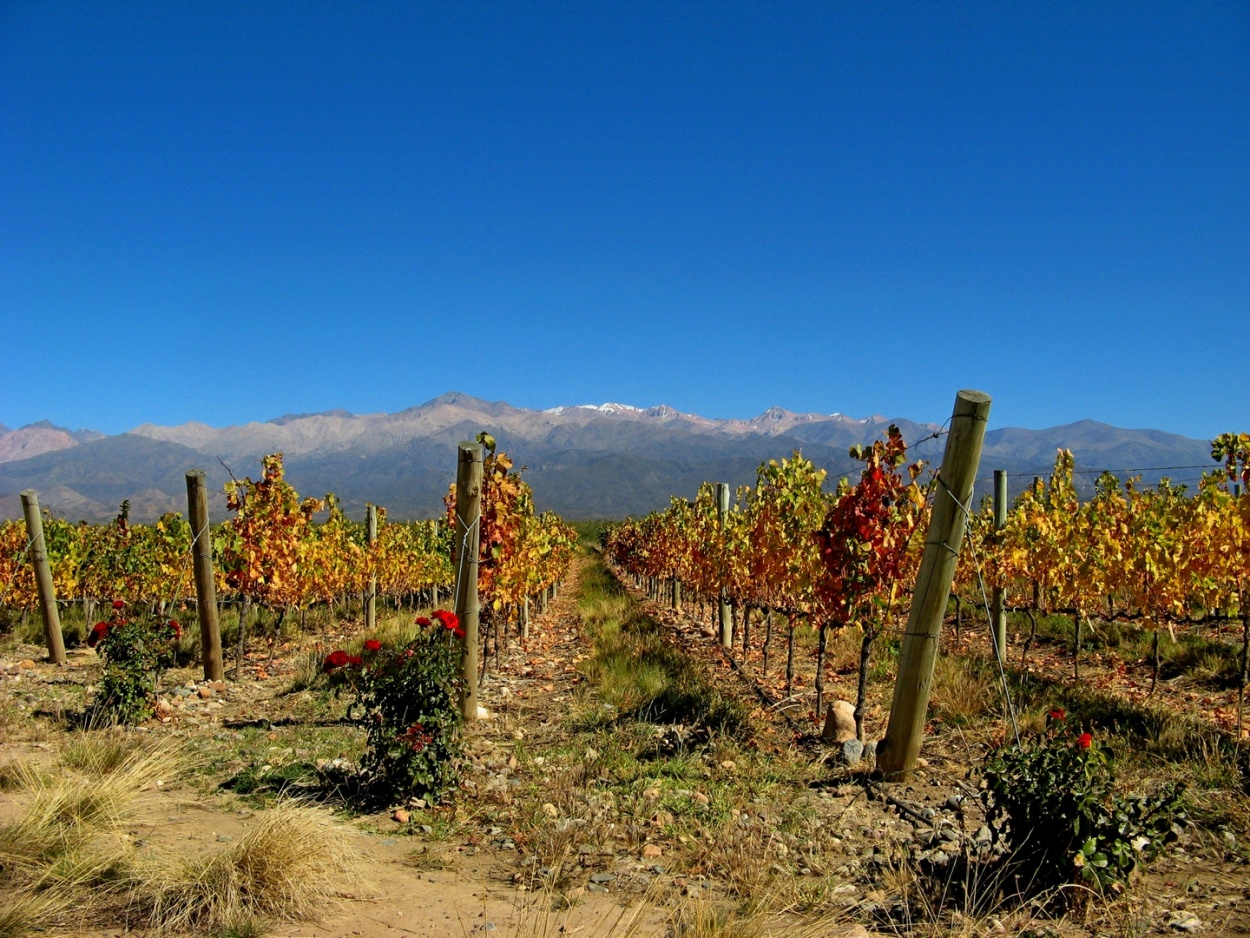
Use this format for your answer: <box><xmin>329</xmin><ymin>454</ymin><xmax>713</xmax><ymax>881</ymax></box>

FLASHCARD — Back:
<box><xmin>451</xmin><ymin>441</ymin><xmax>481</xmax><ymax>723</ymax></box>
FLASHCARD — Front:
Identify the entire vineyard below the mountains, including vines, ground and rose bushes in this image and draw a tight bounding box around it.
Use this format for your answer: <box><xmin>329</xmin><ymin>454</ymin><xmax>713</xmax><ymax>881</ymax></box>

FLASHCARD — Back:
<box><xmin>0</xmin><ymin>422</ymin><xmax>1250</xmax><ymax>938</ymax></box>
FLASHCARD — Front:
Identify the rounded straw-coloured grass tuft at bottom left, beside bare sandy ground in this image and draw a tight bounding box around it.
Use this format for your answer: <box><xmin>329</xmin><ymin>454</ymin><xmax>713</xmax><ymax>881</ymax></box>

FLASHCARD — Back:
<box><xmin>133</xmin><ymin>802</ymin><xmax>361</xmax><ymax>933</ymax></box>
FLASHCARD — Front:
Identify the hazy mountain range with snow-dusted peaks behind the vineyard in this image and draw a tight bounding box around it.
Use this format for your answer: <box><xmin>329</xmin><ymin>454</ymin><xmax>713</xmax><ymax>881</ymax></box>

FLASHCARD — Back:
<box><xmin>0</xmin><ymin>393</ymin><xmax>1215</xmax><ymax>522</ymax></box>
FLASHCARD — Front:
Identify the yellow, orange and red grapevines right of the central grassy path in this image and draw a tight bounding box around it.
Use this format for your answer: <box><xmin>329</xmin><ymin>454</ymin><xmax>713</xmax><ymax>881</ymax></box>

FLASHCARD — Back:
<box><xmin>605</xmin><ymin>428</ymin><xmax>1250</xmax><ymax>739</ymax></box>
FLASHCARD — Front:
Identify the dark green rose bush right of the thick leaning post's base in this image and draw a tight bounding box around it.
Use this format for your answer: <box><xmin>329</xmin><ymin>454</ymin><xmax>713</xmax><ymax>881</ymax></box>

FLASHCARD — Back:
<box><xmin>983</xmin><ymin>710</ymin><xmax>1185</xmax><ymax>894</ymax></box>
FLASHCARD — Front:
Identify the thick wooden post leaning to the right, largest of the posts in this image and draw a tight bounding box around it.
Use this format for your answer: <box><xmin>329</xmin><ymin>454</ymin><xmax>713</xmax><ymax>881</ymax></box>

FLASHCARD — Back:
<box><xmin>876</xmin><ymin>390</ymin><xmax>990</xmax><ymax>780</ymax></box>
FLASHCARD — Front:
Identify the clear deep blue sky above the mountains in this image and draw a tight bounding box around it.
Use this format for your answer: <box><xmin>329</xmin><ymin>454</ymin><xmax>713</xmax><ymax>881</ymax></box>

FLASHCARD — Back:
<box><xmin>0</xmin><ymin>0</ymin><xmax>1250</xmax><ymax>436</ymax></box>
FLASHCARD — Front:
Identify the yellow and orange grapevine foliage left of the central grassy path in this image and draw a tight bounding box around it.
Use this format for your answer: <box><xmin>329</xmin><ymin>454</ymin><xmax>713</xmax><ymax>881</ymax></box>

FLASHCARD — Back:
<box><xmin>0</xmin><ymin>451</ymin><xmax>576</xmax><ymax>670</ymax></box>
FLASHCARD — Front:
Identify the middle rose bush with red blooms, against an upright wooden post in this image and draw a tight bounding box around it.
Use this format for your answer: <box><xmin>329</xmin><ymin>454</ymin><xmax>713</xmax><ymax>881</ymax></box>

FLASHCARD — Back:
<box><xmin>323</xmin><ymin>610</ymin><xmax>464</xmax><ymax>802</ymax></box>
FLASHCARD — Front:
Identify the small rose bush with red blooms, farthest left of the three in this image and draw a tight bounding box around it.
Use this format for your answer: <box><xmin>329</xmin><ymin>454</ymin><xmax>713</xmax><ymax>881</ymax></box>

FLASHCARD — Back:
<box><xmin>86</xmin><ymin>599</ymin><xmax>183</xmax><ymax>724</ymax></box>
